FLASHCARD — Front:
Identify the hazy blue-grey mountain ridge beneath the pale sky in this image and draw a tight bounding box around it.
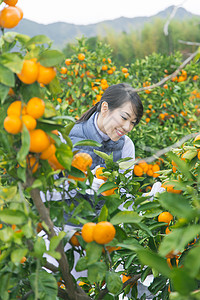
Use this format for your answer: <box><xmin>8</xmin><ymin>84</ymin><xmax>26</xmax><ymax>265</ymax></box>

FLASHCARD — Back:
<box><xmin>5</xmin><ymin>6</ymin><xmax>200</xmax><ymax>48</ymax></box>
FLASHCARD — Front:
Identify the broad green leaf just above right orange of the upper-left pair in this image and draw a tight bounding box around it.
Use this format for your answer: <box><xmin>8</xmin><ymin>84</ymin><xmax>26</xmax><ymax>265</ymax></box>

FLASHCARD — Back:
<box><xmin>38</xmin><ymin>50</ymin><xmax>65</xmax><ymax>67</ymax></box>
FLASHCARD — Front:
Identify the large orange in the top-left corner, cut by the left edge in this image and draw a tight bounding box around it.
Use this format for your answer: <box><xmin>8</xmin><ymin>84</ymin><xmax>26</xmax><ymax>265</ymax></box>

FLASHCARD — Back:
<box><xmin>0</xmin><ymin>6</ymin><xmax>21</xmax><ymax>28</ymax></box>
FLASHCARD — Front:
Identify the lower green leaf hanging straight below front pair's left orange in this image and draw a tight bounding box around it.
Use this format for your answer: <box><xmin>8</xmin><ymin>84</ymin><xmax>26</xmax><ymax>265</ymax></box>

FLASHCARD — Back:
<box><xmin>87</xmin><ymin>262</ymin><xmax>107</xmax><ymax>284</ymax></box>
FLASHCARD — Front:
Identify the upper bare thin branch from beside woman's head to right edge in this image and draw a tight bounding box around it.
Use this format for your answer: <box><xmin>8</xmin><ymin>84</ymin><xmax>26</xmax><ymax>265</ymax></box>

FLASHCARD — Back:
<box><xmin>134</xmin><ymin>49</ymin><xmax>200</xmax><ymax>92</ymax></box>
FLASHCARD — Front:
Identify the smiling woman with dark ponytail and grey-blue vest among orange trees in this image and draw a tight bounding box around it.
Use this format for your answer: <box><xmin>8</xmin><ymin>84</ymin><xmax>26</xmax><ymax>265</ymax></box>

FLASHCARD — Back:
<box><xmin>69</xmin><ymin>83</ymin><xmax>143</xmax><ymax>169</ymax></box>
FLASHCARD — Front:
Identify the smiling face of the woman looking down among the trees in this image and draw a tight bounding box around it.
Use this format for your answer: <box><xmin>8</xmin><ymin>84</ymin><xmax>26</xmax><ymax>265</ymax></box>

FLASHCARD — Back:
<box><xmin>97</xmin><ymin>101</ymin><xmax>137</xmax><ymax>141</ymax></box>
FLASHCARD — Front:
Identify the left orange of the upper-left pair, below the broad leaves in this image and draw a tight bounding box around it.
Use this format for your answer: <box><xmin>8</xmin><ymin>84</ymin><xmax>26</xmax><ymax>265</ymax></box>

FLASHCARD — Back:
<box><xmin>17</xmin><ymin>58</ymin><xmax>39</xmax><ymax>84</ymax></box>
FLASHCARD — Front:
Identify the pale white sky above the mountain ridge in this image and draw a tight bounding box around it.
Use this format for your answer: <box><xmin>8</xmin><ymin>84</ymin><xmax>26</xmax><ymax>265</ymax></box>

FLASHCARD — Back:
<box><xmin>17</xmin><ymin>0</ymin><xmax>200</xmax><ymax>25</ymax></box>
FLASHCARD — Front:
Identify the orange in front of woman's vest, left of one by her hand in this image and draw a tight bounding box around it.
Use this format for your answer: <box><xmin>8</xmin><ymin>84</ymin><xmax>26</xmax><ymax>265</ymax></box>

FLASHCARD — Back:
<box><xmin>72</xmin><ymin>152</ymin><xmax>92</xmax><ymax>172</ymax></box>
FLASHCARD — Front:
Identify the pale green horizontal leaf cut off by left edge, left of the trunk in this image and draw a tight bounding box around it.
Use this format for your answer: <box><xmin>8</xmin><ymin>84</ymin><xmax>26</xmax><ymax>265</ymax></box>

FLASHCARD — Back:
<box><xmin>0</xmin><ymin>208</ymin><xmax>27</xmax><ymax>225</ymax></box>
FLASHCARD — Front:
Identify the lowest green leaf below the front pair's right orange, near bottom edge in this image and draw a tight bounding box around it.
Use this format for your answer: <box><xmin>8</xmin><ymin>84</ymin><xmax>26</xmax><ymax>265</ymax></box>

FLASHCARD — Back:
<box><xmin>106</xmin><ymin>272</ymin><xmax>123</xmax><ymax>295</ymax></box>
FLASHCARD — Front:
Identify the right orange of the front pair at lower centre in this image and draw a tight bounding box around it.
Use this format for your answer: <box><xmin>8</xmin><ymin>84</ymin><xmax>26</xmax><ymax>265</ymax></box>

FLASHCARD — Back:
<box><xmin>93</xmin><ymin>221</ymin><xmax>116</xmax><ymax>245</ymax></box>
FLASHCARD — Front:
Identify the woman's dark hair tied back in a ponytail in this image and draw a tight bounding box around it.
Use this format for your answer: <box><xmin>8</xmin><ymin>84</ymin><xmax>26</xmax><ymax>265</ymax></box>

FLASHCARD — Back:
<box><xmin>76</xmin><ymin>83</ymin><xmax>143</xmax><ymax>125</ymax></box>
